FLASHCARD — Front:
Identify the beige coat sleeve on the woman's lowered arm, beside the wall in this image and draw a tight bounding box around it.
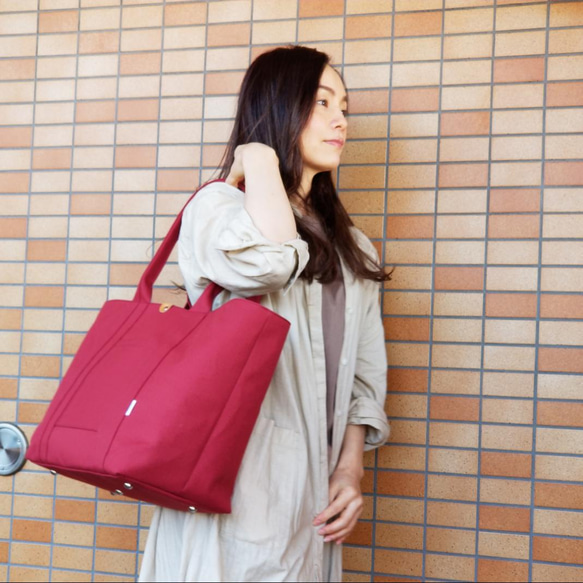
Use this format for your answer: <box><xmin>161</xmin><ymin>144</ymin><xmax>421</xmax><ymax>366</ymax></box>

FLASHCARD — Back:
<box><xmin>348</xmin><ymin>230</ymin><xmax>390</xmax><ymax>450</ymax></box>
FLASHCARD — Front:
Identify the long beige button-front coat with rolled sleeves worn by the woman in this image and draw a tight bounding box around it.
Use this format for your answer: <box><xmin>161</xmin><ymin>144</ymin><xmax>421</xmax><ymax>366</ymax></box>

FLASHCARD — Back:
<box><xmin>140</xmin><ymin>183</ymin><xmax>389</xmax><ymax>581</ymax></box>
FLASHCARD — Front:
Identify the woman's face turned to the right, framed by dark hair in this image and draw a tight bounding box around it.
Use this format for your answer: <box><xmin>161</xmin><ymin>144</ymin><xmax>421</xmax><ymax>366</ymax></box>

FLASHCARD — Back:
<box><xmin>300</xmin><ymin>65</ymin><xmax>347</xmax><ymax>182</ymax></box>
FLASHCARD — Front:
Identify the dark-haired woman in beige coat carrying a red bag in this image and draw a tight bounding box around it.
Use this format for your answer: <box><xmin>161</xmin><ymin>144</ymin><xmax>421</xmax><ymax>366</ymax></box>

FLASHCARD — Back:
<box><xmin>140</xmin><ymin>46</ymin><xmax>388</xmax><ymax>581</ymax></box>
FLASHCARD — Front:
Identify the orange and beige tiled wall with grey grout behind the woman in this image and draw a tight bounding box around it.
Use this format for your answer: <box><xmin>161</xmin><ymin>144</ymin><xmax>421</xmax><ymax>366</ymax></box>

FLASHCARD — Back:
<box><xmin>0</xmin><ymin>0</ymin><xmax>583</xmax><ymax>582</ymax></box>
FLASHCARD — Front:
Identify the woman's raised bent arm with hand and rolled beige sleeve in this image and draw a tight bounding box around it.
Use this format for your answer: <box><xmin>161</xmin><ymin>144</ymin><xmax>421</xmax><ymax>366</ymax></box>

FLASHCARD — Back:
<box><xmin>178</xmin><ymin>143</ymin><xmax>309</xmax><ymax>298</ymax></box>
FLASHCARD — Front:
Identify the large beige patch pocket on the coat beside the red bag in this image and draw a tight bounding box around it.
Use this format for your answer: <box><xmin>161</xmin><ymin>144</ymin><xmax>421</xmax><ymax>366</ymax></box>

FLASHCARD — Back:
<box><xmin>221</xmin><ymin>416</ymin><xmax>307</xmax><ymax>548</ymax></box>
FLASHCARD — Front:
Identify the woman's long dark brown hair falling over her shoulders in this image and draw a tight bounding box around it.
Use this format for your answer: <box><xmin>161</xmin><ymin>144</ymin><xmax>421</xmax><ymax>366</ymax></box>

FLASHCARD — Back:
<box><xmin>220</xmin><ymin>46</ymin><xmax>390</xmax><ymax>283</ymax></box>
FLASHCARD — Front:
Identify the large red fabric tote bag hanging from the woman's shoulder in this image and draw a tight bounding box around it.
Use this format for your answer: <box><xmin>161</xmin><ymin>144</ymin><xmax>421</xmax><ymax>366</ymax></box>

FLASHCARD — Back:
<box><xmin>27</xmin><ymin>181</ymin><xmax>290</xmax><ymax>513</ymax></box>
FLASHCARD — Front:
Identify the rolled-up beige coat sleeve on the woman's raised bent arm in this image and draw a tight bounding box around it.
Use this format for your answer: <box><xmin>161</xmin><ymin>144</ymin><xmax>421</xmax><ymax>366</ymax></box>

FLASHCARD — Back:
<box><xmin>178</xmin><ymin>182</ymin><xmax>308</xmax><ymax>296</ymax></box>
